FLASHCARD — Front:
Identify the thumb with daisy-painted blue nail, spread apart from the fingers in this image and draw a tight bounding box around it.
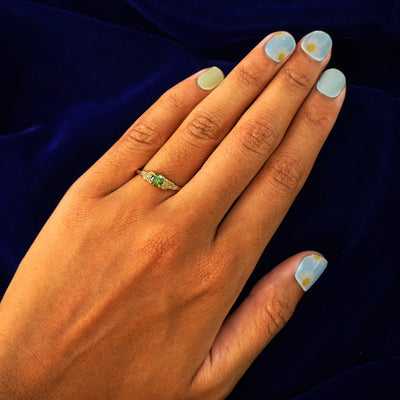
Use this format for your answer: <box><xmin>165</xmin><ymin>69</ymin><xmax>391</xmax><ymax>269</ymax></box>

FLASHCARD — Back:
<box><xmin>192</xmin><ymin>252</ymin><xmax>327</xmax><ymax>399</ymax></box>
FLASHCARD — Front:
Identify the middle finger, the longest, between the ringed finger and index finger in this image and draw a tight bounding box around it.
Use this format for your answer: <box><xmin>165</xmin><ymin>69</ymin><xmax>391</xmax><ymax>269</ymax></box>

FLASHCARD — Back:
<box><xmin>180</xmin><ymin>32</ymin><xmax>331</xmax><ymax>219</ymax></box>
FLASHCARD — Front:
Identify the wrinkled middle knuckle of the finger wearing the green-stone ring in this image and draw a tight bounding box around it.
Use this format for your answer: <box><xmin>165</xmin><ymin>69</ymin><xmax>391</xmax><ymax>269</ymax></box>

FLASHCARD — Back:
<box><xmin>186</xmin><ymin>110</ymin><xmax>223</xmax><ymax>143</ymax></box>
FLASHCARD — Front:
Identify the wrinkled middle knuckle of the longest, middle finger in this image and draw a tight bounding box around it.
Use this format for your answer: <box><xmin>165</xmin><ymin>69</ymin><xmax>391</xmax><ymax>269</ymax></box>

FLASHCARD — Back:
<box><xmin>237</xmin><ymin>118</ymin><xmax>279</xmax><ymax>156</ymax></box>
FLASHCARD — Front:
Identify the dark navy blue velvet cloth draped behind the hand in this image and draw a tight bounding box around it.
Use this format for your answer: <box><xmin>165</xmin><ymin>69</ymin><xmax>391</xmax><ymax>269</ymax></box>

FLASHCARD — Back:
<box><xmin>0</xmin><ymin>0</ymin><xmax>400</xmax><ymax>400</ymax></box>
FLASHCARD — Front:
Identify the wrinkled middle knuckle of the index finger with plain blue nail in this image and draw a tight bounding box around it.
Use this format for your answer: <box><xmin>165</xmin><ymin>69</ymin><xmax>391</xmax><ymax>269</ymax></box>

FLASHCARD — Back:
<box><xmin>270</xmin><ymin>155</ymin><xmax>305</xmax><ymax>193</ymax></box>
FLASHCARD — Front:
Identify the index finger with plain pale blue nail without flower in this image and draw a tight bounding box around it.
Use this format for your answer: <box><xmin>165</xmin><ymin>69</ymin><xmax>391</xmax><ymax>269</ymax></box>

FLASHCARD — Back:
<box><xmin>217</xmin><ymin>70</ymin><xmax>346</xmax><ymax>253</ymax></box>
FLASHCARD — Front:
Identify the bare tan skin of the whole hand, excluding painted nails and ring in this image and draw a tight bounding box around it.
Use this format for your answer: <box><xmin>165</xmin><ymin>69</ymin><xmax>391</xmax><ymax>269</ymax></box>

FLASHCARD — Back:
<box><xmin>0</xmin><ymin>34</ymin><xmax>345</xmax><ymax>400</ymax></box>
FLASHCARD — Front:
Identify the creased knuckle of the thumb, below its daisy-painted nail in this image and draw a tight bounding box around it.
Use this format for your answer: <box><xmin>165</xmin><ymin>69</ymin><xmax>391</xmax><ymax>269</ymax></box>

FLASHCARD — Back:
<box><xmin>259</xmin><ymin>292</ymin><xmax>294</xmax><ymax>335</ymax></box>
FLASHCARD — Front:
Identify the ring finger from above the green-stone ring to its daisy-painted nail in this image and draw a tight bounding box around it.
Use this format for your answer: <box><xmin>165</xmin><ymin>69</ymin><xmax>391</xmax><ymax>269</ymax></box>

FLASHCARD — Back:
<box><xmin>129</xmin><ymin>32</ymin><xmax>295</xmax><ymax>196</ymax></box>
